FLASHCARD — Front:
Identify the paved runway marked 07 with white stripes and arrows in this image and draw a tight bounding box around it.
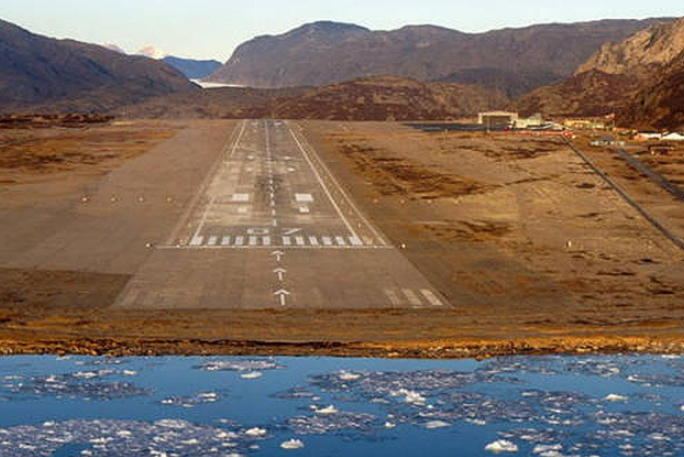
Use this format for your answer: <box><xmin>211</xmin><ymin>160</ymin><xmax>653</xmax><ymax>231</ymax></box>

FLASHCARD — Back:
<box><xmin>115</xmin><ymin>120</ymin><xmax>449</xmax><ymax>309</ymax></box>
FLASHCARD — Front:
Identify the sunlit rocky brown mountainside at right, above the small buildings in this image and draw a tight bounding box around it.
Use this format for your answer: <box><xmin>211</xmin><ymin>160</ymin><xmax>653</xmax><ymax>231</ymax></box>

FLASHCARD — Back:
<box><xmin>513</xmin><ymin>18</ymin><xmax>684</xmax><ymax>119</ymax></box>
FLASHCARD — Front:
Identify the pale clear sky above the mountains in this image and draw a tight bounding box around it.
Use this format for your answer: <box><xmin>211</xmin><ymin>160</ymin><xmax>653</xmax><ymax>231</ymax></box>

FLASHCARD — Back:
<box><xmin>0</xmin><ymin>0</ymin><xmax>684</xmax><ymax>61</ymax></box>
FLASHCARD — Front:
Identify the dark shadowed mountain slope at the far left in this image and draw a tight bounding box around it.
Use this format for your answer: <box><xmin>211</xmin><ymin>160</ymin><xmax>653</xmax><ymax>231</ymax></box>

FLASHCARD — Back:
<box><xmin>0</xmin><ymin>20</ymin><xmax>196</xmax><ymax>112</ymax></box>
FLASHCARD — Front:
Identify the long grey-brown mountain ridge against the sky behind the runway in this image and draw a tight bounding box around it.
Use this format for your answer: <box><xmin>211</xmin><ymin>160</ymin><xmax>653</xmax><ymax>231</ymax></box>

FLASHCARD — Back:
<box><xmin>209</xmin><ymin>19</ymin><xmax>655</xmax><ymax>95</ymax></box>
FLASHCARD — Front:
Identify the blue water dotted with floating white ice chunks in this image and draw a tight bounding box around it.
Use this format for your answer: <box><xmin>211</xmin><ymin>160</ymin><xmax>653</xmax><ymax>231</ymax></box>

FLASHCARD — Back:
<box><xmin>0</xmin><ymin>355</ymin><xmax>684</xmax><ymax>457</ymax></box>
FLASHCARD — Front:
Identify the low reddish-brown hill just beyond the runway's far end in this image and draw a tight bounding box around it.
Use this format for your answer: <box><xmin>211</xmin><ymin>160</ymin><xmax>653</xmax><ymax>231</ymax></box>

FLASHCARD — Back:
<box><xmin>235</xmin><ymin>76</ymin><xmax>507</xmax><ymax>121</ymax></box>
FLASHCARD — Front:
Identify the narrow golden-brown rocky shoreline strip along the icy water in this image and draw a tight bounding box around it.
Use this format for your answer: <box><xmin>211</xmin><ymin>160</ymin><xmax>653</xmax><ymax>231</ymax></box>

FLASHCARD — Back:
<box><xmin>0</xmin><ymin>336</ymin><xmax>684</xmax><ymax>360</ymax></box>
